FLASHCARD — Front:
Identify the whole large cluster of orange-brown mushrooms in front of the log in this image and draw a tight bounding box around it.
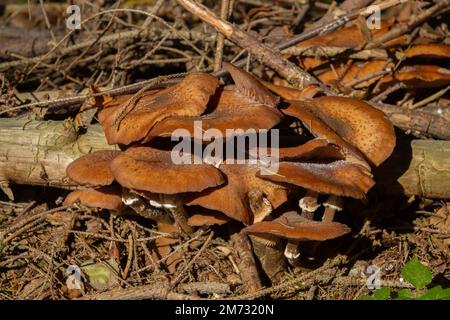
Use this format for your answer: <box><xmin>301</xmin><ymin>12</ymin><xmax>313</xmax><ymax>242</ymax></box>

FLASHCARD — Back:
<box><xmin>65</xmin><ymin>64</ymin><xmax>395</xmax><ymax>264</ymax></box>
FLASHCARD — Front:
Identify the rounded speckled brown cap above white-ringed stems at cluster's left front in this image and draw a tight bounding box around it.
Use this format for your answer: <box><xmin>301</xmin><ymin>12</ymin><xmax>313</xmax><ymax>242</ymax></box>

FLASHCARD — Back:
<box><xmin>110</xmin><ymin>147</ymin><xmax>224</xmax><ymax>194</ymax></box>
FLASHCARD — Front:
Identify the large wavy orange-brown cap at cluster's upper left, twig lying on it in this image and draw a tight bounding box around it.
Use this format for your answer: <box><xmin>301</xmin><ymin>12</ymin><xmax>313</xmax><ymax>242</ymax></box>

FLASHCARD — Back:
<box><xmin>99</xmin><ymin>73</ymin><xmax>219</xmax><ymax>144</ymax></box>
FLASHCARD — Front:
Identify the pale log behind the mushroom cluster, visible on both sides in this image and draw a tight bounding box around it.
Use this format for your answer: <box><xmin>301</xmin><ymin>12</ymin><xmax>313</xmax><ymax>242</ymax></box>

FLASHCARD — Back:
<box><xmin>0</xmin><ymin>118</ymin><xmax>450</xmax><ymax>199</ymax></box>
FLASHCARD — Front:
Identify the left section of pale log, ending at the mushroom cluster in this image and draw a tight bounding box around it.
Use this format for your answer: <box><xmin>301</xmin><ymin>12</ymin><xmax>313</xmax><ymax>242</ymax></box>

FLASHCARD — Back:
<box><xmin>0</xmin><ymin>118</ymin><xmax>117</xmax><ymax>198</ymax></box>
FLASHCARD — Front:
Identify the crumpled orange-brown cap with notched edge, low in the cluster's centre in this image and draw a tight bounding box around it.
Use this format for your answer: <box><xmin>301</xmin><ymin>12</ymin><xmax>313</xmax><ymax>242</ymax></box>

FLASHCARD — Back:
<box><xmin>186</xmin><ymin>163</ymin><xmax>287</xmax><ymax>224</ymax></box>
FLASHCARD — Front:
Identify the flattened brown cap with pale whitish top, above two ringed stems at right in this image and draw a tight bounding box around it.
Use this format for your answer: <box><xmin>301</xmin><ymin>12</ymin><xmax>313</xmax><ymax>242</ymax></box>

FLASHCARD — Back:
<box><xmin>258</xmin><ymin>161</ymin><xmax>375</xmax><ymax>199</ymax></box>
